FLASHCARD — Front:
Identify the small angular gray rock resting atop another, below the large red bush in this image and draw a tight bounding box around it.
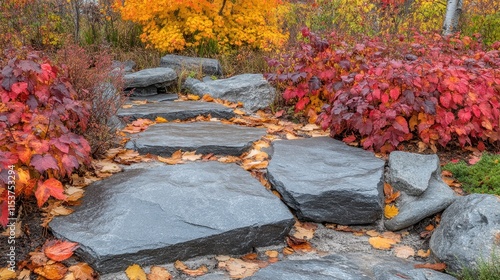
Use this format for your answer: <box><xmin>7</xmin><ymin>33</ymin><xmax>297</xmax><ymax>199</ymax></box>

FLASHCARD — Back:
<box><xmin>386</xmin><ymin>151</ymin><xmax>441</xmax><ymax>196</ymax></box>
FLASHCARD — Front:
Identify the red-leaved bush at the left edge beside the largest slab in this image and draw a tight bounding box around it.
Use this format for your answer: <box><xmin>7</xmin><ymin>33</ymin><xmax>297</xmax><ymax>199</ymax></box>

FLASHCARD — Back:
<box><xmin>0</xmin><ymin>52</ymin><xmax>90</xmax><ymax>226</ymax></box>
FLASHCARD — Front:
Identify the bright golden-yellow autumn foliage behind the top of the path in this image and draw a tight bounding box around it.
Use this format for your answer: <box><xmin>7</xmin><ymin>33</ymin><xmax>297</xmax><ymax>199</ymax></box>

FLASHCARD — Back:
<box><xmin>116</xmin><ymin>0</ymin><xmax>287</xmax><ymax>52</ymax></box>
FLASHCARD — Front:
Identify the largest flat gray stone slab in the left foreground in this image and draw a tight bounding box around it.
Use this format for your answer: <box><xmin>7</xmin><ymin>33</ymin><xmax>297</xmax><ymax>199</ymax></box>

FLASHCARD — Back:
<box><xmin>50</xmin><ymin>162</ymin><xmax>294</xmax><ymax>273</ymax></box>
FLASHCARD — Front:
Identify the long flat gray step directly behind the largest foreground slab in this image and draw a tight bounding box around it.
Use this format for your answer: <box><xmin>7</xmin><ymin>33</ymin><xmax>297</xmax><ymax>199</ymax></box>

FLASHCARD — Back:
<box><xmin>125</xmin><ymin>122</ymin><xmax>266</xmax><ymax>156</ymax></box>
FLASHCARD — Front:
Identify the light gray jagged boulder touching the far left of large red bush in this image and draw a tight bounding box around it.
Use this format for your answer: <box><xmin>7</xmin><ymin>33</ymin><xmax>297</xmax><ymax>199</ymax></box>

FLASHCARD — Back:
<box><xmin>184</xmin><ymin>74</ymin><xmax>276</xmax><ymax>111</ymax></box>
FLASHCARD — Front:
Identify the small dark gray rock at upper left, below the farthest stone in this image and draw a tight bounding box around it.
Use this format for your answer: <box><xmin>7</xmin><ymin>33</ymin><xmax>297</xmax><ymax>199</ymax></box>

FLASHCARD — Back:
<box><xmin>123</xmin><ymin>67</ymin><xmax>177</xmax><ymax>95</ymax></box>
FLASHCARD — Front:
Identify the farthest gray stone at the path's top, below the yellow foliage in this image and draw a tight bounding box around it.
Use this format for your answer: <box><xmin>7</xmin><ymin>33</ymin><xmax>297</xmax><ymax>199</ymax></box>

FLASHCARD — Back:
<box><xmin>160</xmin><ymin>54</ymin><xmax>222</xmax><ymax>77</ymax></box>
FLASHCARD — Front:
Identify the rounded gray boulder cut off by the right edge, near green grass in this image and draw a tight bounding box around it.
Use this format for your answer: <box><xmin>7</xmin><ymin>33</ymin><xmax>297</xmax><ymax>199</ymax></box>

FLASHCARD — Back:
<box><xmin>429</xmin><ymin>194</ymin><xmax>500</xmax><ymax>272</ymax></box>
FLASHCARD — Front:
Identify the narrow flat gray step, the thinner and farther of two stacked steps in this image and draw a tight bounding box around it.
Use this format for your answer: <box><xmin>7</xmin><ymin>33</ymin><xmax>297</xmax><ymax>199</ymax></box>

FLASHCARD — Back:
<box><xmin>117</xmin><ymin>101</ymin><xmax>234</xmax><ymax>121</ymax></box>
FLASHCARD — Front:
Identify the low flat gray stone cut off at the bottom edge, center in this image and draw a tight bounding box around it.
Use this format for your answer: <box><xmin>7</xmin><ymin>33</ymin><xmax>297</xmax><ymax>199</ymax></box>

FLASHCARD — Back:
<box><xmin>250</xmin><ymin>255</ymin><xmax>372</xmax><ymax>280</ymax></box>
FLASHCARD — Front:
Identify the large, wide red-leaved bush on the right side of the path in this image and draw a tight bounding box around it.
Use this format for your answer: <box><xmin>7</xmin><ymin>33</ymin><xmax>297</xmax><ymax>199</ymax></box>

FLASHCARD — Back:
<box><xmin>267</xmin><ymin>29</ymin><xmax>500</xmax><ymax>152</ymax></box>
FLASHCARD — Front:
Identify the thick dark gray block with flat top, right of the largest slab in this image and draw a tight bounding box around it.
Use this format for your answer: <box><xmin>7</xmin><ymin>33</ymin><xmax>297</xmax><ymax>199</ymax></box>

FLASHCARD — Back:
<box><xmin>268</xmin><ymin>137</ymin><xmax>384</xmax><ymax>225</ymax></box>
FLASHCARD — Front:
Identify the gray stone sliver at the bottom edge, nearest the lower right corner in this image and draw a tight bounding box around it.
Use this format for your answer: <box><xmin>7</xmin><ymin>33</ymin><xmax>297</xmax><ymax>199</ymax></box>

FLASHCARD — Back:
<box><xmin>373</xmin><ymin>261</ymin><xmax>456</xmax><ymax>280</ymax></box>
